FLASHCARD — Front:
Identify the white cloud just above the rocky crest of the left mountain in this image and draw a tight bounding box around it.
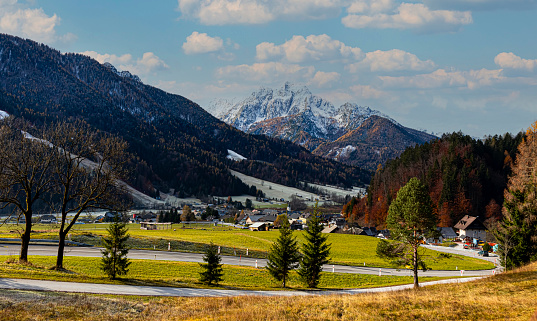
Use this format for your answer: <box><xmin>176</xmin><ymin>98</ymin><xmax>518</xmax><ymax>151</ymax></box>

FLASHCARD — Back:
<box><xmin>80</xmin><ymin>51</ymin><xmax>169</xmax><ymax>75</ymax></box>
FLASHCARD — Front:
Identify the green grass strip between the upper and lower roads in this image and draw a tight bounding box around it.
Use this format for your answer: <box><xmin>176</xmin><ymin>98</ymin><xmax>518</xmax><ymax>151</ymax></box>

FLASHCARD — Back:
<box><xmin>0</xmin><ymin>256</ymin><xmax>441</xmax><ymax>290</ymax></box>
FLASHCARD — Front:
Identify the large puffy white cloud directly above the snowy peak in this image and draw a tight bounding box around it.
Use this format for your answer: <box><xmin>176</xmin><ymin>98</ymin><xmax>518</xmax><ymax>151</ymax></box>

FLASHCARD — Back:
<box><xmin>256</xmin><ymin>34</ymin><xmax>362</xmax><ymax>63</ymax></box>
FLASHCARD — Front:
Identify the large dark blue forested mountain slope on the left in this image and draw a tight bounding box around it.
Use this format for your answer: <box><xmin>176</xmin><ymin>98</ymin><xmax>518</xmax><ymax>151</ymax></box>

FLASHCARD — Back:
<box><xmin>0</xmin><ymin>34</ymin><xmax>369</xmax><ymax>196</ymax></box>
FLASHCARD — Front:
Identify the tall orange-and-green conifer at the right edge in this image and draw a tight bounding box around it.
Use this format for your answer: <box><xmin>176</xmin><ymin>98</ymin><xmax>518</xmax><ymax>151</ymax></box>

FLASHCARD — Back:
<box><xmin>496</xmin><ymin>122</ymin><xmax>537</xmax><ymax>269</ymax></box>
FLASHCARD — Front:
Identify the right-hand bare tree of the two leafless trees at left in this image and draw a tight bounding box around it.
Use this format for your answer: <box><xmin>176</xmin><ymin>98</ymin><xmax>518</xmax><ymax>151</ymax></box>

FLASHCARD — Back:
<box><xmin>45</xmin><ymin>122</ymin><xmax>129</xmax><ymax>269</ymax></box>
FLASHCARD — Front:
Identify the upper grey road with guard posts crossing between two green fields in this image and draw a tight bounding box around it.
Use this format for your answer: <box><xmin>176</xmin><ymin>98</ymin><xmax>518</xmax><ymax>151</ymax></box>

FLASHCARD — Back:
<box><xmin>0</xmin><ymin>244</ymin><xmax>496</xmax><ymax>277</ymax></box>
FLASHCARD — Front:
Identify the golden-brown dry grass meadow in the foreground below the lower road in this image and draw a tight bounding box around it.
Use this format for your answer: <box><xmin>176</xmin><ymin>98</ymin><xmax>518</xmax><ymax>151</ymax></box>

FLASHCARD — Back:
<box><xmin>0</xmin><ymin>263</ymin><xmax>537</xmax><ymax>321</ymax></box>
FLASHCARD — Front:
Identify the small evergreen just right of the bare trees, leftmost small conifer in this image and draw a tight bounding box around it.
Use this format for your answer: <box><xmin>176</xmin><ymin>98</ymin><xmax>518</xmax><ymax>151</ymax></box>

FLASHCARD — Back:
<box><xmin>101</xmin><ymin>217</ymin><xmax>131</xmax><ymax>279</ymax></box>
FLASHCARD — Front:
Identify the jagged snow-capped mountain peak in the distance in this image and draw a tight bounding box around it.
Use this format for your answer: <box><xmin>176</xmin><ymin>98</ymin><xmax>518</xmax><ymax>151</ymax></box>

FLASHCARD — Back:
<box><xmin>207</xmin><ymin>82</ymin><xmax>396</xmax><ymax>140</ymax></box>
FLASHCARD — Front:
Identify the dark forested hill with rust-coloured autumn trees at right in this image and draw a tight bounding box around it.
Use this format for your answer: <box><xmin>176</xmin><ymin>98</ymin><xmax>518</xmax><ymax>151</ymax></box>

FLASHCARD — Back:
<box><xmin>343</xmin><ymin>133</ymin><xmax>523</xmax><ymax>227</ymax></box>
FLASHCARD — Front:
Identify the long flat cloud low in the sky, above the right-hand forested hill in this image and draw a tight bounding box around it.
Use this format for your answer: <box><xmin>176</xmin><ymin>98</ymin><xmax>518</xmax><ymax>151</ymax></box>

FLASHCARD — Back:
<box><xmin>379</xmin><ymin>69</ymin><xmax>505</xmax><ymax>89</ymax></box>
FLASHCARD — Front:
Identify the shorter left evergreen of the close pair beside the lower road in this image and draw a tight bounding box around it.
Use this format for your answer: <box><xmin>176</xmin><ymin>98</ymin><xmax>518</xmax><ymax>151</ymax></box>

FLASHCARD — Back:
<box><xmin>267</xmin><ymin>216</ymin><xmax>300</xmax><ymax>288</ymax></box>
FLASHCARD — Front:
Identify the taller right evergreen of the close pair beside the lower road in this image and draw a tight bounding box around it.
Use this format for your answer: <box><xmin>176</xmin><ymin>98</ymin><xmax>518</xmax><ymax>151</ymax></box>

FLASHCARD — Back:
<box><xmin>298</xmin><ymin>204</ymin><xmax>331</xmax><ymax>288</ymax></box>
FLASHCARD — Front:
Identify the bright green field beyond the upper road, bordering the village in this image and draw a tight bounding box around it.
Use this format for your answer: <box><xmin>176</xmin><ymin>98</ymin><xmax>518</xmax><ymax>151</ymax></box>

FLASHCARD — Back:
<box><xmin>0</xmin><ymin>224</ymin><xmax>494</xmax><ymax>270</ymax></box>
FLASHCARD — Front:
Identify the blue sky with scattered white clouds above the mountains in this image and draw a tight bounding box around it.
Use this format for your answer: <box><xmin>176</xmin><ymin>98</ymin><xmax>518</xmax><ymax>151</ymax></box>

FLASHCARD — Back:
<box><xmin>0</xmin><ymin>0</ymin><xmax>537</xmax><ymax>138</ymax></box>
